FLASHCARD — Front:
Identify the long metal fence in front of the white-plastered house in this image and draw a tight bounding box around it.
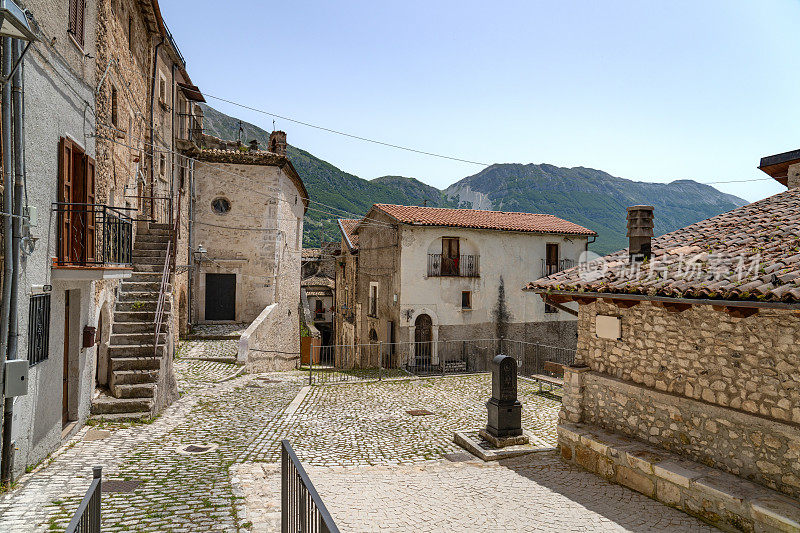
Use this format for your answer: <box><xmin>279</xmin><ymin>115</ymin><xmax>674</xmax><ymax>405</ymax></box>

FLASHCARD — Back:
<box><xmin>303</xmin><ymin>339</ymin><xmax>575</xmax><ymax>385</ymax></box>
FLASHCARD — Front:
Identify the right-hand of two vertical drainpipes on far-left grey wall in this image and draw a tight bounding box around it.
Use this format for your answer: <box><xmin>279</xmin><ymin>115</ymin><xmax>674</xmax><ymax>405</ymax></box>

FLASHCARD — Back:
<box><xmin>0</xmin><ymin>40</ymin><xmax>25</xmax><ymax>485</ymax></box>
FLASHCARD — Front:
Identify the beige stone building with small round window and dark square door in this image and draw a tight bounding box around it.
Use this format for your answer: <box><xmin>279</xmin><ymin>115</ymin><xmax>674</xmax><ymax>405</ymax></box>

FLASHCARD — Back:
<box><xmin>192</xmin><ymin>131</ymin><xmax>308</xmax><ymax>369</ymax></box>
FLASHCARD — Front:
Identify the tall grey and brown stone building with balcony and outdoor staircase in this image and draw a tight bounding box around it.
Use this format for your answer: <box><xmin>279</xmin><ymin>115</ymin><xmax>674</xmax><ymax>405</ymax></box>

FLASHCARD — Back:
<box><xmin>0</xmin><ymin>0</ymin><xmax>203</xmax><ymax>473</ymax></box>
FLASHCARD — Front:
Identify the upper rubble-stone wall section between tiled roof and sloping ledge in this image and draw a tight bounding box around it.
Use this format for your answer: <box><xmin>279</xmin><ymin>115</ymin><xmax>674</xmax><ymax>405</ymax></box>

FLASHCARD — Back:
<box><xmin>578</xmin><ymin>302</ymin><xmax>800</xmax><ymax>423</ymax></box>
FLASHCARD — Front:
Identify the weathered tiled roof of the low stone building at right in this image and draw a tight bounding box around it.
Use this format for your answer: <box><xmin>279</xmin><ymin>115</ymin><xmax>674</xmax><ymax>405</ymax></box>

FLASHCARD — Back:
<box><xmin>526</xmin><ymin>189</ymin><xmax>800</xmax><ymax>303</ymax></box>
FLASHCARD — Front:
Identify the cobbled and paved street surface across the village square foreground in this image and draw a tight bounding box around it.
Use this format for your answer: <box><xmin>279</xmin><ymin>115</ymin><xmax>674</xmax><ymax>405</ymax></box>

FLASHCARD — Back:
<box><xmin>0</xmin><ymin>341</ymin><xmax>703</xmax><ymax>531</ymax></box>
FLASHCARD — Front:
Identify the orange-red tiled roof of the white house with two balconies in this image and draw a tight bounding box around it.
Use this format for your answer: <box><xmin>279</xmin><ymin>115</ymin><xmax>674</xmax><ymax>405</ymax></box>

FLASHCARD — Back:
<box><xmin>373</xmin><ymin>204</ymin><xmax>597</xmax><ymax>236</ymax></box>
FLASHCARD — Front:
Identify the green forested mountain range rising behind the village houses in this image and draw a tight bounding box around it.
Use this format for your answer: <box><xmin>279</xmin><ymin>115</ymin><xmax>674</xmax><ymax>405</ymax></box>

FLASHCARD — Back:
<box><xmin>198</xmin><ymin>105</ymin><xmax>747</xmax><ymax>254</ymax></box>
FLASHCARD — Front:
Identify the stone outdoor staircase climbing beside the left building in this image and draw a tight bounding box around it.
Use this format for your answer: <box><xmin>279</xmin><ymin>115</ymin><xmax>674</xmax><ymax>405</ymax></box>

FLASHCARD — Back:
<box><xmin>92</xmin><ymin>223</ymin><xmax>172</xmax><ymax>420</ymax></box>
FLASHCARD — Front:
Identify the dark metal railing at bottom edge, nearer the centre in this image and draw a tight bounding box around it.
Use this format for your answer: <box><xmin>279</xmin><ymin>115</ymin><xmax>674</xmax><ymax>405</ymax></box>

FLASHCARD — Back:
<box><xmin>281</xmin><ymin>440</ymin><xmax>339</xmax><ymax>533</ymax></box>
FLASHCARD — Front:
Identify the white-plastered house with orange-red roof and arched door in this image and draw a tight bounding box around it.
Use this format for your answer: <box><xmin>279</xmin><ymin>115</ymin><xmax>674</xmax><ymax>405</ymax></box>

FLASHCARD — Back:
<box><xmin>337</xmin><ymin>204</ymin><xmax>595</xmax><ymax>366</ymax></box>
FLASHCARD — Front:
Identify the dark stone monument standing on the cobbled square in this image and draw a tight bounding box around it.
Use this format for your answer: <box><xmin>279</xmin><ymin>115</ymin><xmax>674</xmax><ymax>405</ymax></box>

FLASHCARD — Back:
<box><xmin>479</xmin><ymin>354</ymin><xmax>529</xmax><ymax>448</ymax></box>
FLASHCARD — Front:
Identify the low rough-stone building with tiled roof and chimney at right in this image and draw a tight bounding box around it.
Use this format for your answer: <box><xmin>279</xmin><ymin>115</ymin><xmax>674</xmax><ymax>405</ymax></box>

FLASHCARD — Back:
<box><xmin>527</xmin><ymin>154</ymin><xmax>800</xmax><ymax>531</ymax></box>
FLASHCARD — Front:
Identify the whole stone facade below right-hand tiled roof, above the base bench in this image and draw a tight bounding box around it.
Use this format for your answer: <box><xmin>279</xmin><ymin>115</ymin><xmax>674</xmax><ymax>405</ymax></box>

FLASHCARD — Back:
<box><xmin>561</xmin><ymin>300</ymin><xmax>800</xmax><ymax>497</ymax></box>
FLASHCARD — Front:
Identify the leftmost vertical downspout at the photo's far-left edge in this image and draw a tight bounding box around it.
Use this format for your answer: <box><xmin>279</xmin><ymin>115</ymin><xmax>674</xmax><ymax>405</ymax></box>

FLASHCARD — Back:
<box><xmin>0</xmin><ymin>37</ymin><xmax>14</xmax><ymax>482</ymax></box>
